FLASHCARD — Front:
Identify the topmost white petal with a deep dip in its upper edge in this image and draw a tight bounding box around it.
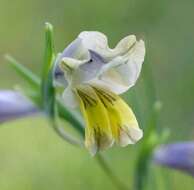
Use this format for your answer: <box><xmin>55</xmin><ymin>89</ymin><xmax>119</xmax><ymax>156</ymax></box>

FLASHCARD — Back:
<box><xmin>79</xmin><ymin>32</ymin><xmax>136</xmax><ymax>60</ymax></box>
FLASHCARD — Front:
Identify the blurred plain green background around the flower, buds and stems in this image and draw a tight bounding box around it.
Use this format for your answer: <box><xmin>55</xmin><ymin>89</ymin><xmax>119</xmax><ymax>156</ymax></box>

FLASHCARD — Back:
<box><xmin>0</xmin><ymin>0</ymin><xmax>194</xmax><ymax>190</ymax></box>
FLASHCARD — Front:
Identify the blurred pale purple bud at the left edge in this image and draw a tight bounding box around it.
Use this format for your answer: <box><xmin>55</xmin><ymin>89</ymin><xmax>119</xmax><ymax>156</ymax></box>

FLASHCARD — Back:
<box><xmin>0</xmin><ymin>90</ymin><xmax>38</xmax><ymax>123</ymax></box>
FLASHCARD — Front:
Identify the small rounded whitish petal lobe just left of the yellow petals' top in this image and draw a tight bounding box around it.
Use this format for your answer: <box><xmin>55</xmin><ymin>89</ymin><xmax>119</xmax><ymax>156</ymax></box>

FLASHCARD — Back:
<box><xmin>62</xmin><ymin>86</ymin><xmax>79</xmax><ymax>108</ymax></box>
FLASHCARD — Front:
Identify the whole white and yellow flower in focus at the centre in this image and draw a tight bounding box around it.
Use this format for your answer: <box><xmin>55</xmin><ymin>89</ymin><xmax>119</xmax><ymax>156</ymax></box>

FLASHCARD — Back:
<box><xmin>54</xmin><ymin>32</ymin><xmax>145</xmax><ymax>155</ymax></box>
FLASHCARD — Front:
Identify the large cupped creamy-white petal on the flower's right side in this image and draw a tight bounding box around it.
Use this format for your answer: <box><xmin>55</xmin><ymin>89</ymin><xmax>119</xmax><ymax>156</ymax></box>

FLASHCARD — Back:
<box><xmin>90</xmin><ymin>40</ymin><xmax>145</xmax><ymax>94</ymax></box>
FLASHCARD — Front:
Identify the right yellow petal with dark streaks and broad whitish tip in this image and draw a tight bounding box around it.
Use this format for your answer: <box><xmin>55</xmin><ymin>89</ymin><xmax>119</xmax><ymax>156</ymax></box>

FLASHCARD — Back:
<box><xmin>93</xmin><ymin>87</ymin><xmax>143</xmax><ymax>146</ymax></box>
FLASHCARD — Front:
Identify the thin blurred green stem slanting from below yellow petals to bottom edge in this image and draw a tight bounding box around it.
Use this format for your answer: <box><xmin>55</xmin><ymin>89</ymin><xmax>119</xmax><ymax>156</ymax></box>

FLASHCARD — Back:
<box><xmin>95</xmin><ymin>154</ymin><xmax>129</xmax><ymax>190</ymax></box>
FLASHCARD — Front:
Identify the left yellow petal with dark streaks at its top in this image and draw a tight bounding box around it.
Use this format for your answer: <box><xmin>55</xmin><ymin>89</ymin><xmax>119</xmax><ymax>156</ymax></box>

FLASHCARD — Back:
<box><xmin>76</xmin><ymin>85</ymin><xmax>113</xmax><ymax>155</ymax></box>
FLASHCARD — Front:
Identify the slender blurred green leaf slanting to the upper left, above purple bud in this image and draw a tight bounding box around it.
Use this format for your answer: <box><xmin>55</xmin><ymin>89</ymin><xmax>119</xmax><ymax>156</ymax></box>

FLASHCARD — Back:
<box><xmin>5</xmin><ymin>55</ymin><xmax>40</xmax><ymax>87</ymax></box>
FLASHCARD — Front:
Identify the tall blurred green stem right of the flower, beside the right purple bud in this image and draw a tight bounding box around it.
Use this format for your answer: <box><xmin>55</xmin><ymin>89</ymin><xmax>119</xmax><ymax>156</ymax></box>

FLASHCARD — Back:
<box><xmin>134</xmin><ymin>60</ymin><xmax>160</xmax><ymax>190</ymax></box>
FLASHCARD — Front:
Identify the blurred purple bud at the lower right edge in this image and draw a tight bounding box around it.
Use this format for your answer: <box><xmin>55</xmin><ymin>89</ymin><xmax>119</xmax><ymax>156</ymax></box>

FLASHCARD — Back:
<box><xmin>153</xmin><ymin>141</ymin><xmax>194</xmax><ymax>176</ymax></box>
